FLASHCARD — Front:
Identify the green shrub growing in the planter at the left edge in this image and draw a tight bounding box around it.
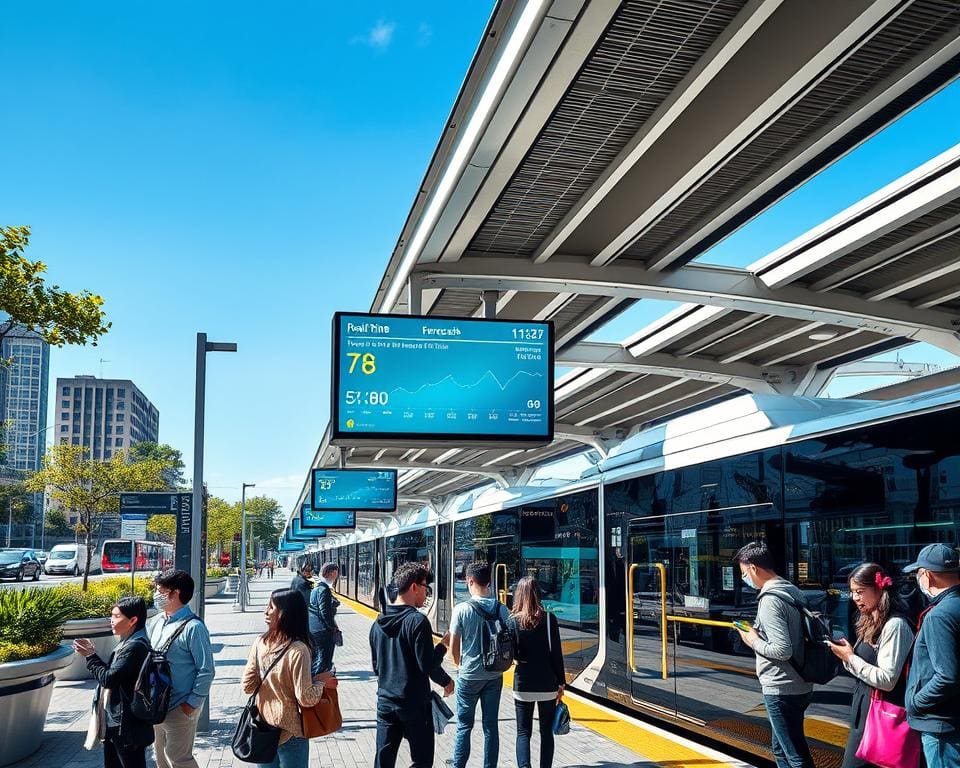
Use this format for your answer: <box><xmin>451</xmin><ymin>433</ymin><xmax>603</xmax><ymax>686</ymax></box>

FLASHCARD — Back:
<box><xmin>0</xmin><ymin>587</ymin><xmax>73</xmax><ymax>662</ymax></box>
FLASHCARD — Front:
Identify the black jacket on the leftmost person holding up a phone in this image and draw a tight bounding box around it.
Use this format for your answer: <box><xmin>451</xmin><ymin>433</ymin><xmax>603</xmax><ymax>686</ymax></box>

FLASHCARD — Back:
<box><xmin>87</xmin><ymin>632</ymin><xmax>153</xmax><ymax>749</ymax></box>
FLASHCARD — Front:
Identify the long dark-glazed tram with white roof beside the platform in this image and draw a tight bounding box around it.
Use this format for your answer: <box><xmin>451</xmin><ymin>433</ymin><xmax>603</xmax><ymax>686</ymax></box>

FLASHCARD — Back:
<box><xmin>299</xmin><ymin>387</ymin><xmax>960</xmax><ymax>768</ymax></box>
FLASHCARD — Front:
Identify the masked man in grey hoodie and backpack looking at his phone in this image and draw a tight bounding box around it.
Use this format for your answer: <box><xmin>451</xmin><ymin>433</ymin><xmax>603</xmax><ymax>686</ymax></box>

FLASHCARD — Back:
<box><xmin>734</xmin><ymin>541</ymin><xmax>814</xmax><ymax>768</ymax></box>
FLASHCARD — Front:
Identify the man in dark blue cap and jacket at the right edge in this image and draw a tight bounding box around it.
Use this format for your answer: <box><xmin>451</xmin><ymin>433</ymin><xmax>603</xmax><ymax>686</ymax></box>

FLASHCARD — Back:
<box><xmin>903</xmin><ymin>544</ymin><xmax>960</xmax><ymax>768</ymax></box>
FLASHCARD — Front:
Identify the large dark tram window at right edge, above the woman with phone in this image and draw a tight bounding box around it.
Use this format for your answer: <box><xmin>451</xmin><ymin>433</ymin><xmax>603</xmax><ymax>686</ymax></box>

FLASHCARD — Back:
<box><xmin>784</xmin><ymin>410</ymin><xmax>960</xmax><ymax>636</ymax></box>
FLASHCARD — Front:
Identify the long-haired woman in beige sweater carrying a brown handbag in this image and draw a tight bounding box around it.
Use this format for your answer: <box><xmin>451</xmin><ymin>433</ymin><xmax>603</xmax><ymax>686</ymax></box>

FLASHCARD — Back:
<box><xmin>243</xmin><ymin>589</ymin><xmax>337</xmax><ymax>768</ymax></box>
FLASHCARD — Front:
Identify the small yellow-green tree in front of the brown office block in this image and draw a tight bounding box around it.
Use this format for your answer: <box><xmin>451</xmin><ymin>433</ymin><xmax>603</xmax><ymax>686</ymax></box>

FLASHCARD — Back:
<box><xmin>24</xmin><ymin>445</ymin><xmax>168</xmax><ymax>590</ymax></box>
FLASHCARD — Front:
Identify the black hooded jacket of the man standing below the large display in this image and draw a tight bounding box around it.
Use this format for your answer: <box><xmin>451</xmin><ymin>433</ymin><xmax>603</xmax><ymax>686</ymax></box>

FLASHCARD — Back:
<box><xmin>370</xmin><ymin>605</ymin><xmax>450</xmax><ymax>705</ymax></box>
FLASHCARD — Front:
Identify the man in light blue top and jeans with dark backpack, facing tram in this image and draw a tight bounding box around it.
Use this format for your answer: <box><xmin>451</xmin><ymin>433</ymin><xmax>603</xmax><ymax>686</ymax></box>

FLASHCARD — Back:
<box><xmin>450</xmin><ymin>563</ymin><xmax>513</xmax><ymax>768</ymax></box>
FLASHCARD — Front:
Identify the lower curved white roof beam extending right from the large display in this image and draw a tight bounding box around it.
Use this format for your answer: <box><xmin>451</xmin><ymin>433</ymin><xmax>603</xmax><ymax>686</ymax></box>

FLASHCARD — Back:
<box><xmin>556</xmin><ymin>341</ymin><xmax>802</xmax><ymax>392</ymax></box>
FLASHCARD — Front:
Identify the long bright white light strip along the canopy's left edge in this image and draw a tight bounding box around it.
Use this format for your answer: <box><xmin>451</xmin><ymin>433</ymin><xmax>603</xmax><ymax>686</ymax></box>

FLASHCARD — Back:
<box><xmin>380</xmin><ymin>0</ymin><xmax>546</xmax><ymax>312</ymax></box>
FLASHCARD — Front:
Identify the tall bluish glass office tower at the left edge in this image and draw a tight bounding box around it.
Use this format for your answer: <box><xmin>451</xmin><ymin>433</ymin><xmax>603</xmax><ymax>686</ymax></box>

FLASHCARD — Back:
<box><xmin>0</xmin><ymin>328</ymin><xmax>50</xmax><ymax>480</ymax></box>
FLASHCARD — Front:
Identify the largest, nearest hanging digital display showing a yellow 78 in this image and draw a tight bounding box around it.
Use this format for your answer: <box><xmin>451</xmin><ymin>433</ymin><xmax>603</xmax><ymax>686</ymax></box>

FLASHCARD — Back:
<box><xmin>331</xmin><ymin>312</ymin><xmax>553</xmax><ymax>445</ymax></box>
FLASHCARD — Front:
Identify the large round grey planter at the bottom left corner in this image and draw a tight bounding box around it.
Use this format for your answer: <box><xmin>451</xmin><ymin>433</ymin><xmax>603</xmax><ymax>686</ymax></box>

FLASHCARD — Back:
<box><xmin>0</xmin><ymin>643</ymin><xmax>75</xmax><ymax>765</ymax></box>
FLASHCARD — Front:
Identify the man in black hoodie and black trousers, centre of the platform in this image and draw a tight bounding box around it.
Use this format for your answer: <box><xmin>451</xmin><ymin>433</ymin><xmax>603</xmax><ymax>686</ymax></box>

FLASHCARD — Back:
<box><xmin>370</xmin><ymin>562</ymin><xmax>453</xmax><ymax>768</ymax></box>
